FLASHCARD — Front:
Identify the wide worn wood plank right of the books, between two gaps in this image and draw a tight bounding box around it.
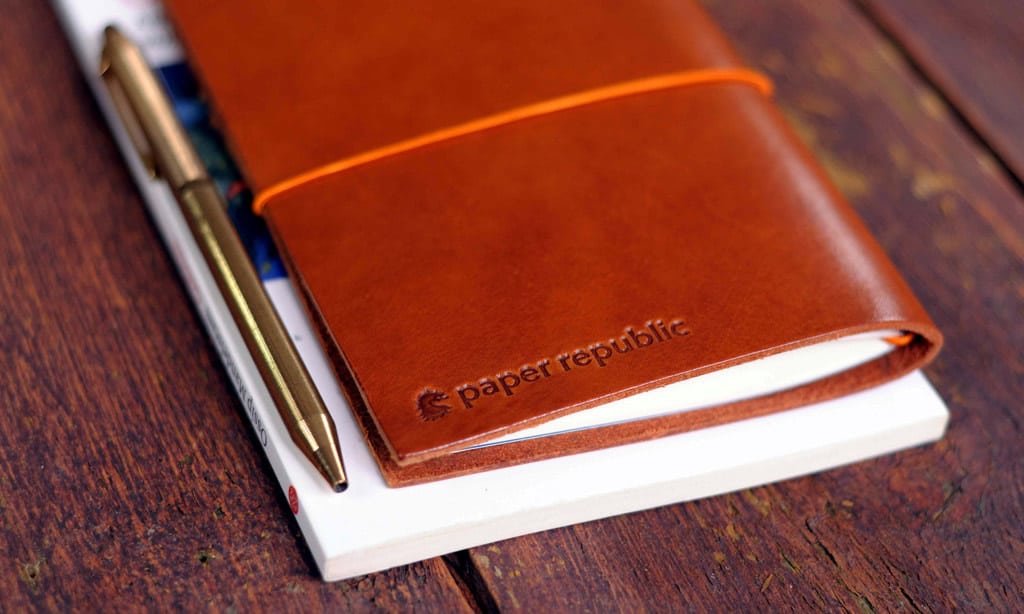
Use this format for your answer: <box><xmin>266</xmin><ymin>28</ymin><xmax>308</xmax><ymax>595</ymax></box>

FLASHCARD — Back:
<box><xmin>471</xmin><ymin>0</ymin><xmax>1024</xmax><ymax>612</ymax></box>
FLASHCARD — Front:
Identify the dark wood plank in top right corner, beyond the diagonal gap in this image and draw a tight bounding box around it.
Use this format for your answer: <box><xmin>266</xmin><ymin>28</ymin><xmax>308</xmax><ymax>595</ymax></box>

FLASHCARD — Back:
<box><xmin>859</xmin><ymin>0</ymin><xmax>1024</xmax><ymax>184</ymax></box>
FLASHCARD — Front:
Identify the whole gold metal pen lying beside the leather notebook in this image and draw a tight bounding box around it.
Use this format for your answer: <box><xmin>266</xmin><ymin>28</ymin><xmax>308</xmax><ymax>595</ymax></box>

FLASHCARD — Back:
<box><xmin>100</xmin><ymin>27</ymin><xmax>348</xmax><ymax>492</ymax></box>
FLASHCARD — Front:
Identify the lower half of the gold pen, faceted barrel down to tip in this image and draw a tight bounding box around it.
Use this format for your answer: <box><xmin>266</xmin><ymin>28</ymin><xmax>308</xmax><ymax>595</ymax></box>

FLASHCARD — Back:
<box><xmin>177</xmin><ymin>179</ymin><xmax>346</xmax><ymax>490</ymax></box>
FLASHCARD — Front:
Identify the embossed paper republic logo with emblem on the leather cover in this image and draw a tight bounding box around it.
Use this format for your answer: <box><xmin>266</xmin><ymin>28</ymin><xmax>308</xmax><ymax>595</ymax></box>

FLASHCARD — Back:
<box><xmin>416</xmin><ymin>318</ymin><xmax>692</xmax><ymax>422</ymax></box>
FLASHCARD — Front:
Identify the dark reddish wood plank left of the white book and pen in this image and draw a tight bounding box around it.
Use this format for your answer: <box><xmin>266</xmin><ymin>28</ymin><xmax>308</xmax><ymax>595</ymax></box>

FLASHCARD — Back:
<box><xmin>0</xmin><ymin>2</ymin><xmax>468</xmax><ymax>611</ymax></box>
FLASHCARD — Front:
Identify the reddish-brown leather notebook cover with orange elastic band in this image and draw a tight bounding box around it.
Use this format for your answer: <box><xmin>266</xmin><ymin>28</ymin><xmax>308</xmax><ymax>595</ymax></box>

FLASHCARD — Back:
<box><xmin>161</xmin><ymin>0</ymin><xmax>941</xmax><ymax>485</ymax></box>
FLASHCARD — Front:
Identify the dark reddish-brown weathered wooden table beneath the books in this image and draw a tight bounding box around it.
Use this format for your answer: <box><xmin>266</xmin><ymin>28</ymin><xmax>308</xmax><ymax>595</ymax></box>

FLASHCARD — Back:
<box><xmin>0</xmin><ymin>0</ymin><xmax>1024</xmax><ymax>612</ymax></box>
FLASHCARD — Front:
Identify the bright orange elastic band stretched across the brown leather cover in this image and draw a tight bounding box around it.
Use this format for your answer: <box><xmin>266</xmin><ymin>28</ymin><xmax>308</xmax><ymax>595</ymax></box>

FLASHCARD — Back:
<box><xmin>253</xmin><ymin>69</ymin><xmax>772</xmax><ymax>214</ymax></box>
